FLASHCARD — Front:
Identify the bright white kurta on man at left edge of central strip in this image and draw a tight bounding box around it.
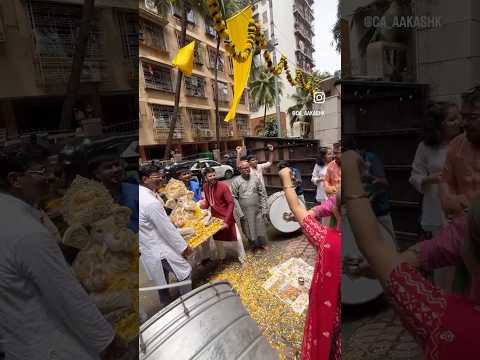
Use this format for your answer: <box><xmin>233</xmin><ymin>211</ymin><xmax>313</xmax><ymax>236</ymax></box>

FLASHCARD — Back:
<box><xmin>138</xmin><ymin>186</ymin><xmax>192</xmax><ymax>286</ymax></box>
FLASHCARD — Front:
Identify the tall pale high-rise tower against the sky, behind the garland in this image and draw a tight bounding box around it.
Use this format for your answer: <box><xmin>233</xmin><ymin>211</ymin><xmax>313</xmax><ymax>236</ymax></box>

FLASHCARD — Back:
<box><xmin>251</xmin><ymin>0</ymin><xmax>315</xmax><ymax>136</ymax></box>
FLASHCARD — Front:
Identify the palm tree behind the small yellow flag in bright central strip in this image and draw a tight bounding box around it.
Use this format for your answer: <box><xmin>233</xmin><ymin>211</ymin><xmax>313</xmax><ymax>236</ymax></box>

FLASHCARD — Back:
<box><xmin>161</xmin><ymin>0</ymin><xmax>208</xmax><ymax>160</ymax></box>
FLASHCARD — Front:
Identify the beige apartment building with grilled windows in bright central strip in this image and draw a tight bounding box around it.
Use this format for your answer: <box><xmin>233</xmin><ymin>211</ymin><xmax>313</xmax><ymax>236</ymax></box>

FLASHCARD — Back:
<box><xmin>139</xmin><ymin>0</ymin><xmax>250</xmax><ymax>160</ymax></box>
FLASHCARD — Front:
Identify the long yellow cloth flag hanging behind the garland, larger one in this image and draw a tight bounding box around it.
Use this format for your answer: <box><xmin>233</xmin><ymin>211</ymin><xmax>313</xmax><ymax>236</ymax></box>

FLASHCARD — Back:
<box><xmin>225</xmin><ymin>6</ymin><xmax>253</xmax><ymax>122</ymax></box>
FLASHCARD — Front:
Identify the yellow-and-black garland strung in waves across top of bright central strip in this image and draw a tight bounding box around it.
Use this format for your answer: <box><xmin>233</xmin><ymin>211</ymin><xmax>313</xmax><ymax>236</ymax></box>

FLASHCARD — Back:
<box><xmin>208</xmin><ymin>0</ymin><xmax>320</xmax><ymax>95</ymax></box>
